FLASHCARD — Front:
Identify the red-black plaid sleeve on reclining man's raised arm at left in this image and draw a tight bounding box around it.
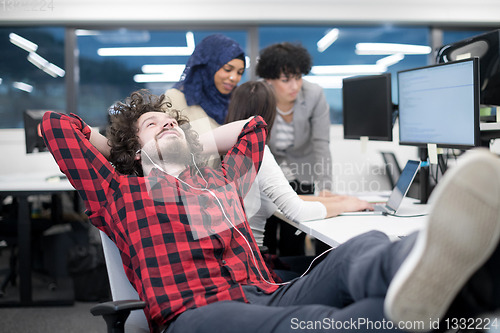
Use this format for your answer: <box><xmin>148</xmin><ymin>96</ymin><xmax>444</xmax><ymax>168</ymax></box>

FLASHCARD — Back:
<box><xmin>41</xmin><ymin>111</ymin><xmax>119</xmax><ymax>227</ymax></box>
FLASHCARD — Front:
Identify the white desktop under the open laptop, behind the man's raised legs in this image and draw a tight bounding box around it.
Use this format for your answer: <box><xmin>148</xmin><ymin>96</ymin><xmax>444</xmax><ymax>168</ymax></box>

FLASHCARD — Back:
<box><xmin>275</xmin><ymin>198</ymin><xmax>430</xmax><ymax>247</ymax></box>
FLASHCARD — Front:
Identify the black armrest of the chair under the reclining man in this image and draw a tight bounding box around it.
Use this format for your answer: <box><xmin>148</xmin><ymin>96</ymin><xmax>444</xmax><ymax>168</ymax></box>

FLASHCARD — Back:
<box><xmin>90</xmin><ymin>300</ymin><xmax>146</xmax><ymax>333</ymax></box>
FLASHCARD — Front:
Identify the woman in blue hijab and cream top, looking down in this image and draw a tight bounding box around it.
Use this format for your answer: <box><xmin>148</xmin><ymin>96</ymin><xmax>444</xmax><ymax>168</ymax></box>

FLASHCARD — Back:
<box><xmin>165</xmin><ymin>34</ymin><xmax>245</xmax><ymax>134</ymax></box>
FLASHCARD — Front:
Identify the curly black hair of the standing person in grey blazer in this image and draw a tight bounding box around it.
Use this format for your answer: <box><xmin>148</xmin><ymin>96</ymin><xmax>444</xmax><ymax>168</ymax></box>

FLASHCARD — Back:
<box><xmin>256</xmin><ymin>42</ymin><xmax>312</xmax><ymax>80</ymax></box>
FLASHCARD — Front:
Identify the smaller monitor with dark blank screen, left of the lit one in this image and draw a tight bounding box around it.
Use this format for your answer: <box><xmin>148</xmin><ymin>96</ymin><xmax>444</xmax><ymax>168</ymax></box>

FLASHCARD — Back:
<box><xmin>342</xmin><ymin>73</ymin><xmax>394</xmax><ymax>141</ymax></box>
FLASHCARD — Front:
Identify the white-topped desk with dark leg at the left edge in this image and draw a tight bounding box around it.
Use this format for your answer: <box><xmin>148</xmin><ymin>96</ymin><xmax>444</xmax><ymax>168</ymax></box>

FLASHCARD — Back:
<box><xmin>0</xmin><ymin>173</ymin><xmax>74</xmax><ymax>306</ymax></box>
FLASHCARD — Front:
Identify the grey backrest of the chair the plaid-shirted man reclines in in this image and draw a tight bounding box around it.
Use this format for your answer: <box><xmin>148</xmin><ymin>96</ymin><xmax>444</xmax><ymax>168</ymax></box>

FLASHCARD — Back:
<box><xmin>100</xmin><ymin>231</ymin><xmax>149</xmax><ymax>333</ymax></box>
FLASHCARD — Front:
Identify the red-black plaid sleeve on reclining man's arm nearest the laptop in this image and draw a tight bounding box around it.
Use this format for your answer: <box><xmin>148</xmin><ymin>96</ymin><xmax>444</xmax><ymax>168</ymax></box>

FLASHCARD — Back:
<box><xmin>222</xmin><ymin>116</ymin><xmax>267</xmax><ymax>198</ymax></box>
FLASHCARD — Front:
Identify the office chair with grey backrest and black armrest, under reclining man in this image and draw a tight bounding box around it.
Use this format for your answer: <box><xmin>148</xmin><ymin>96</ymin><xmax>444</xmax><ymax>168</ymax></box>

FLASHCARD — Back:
<box><xmin>90</xmin><ymin>231</ymin><xmax>149</xmax><ymax>333</ymax></box>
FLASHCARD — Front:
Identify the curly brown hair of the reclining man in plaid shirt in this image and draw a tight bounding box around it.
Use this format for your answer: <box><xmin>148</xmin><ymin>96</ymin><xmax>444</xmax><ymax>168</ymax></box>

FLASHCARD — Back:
<box><xmin>107</xmin><ymin>89</ymin><xmax>203</xmax><ymax>177</ymax></box>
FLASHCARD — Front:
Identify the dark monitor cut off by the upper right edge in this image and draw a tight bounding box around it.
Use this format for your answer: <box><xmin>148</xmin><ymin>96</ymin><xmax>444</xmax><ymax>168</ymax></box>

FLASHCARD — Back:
<box><xmin>436</xmin><ymin>30</ymin><xmax>500</xmax><ymax>106</ymax></box>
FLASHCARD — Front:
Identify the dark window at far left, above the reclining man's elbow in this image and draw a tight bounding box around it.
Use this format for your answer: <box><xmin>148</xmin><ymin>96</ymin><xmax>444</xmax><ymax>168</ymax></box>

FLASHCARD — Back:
<box><xmin>0</xmin><ymin>27</ymin><xmax>66</xmax><ymax>128</ymax></box>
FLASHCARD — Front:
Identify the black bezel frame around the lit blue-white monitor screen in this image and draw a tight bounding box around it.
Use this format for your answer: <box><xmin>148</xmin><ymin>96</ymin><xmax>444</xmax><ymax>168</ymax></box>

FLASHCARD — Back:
<box><xmin>397</xmin><ymin>57</ymin><xmax>480</xmax><ymax>149</ymax></box>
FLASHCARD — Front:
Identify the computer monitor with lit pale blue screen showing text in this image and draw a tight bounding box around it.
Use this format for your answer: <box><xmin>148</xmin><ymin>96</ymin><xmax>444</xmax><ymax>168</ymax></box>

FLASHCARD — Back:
<box><xmin>398</xmin><ymin>58</ymin><xmax>479</xmax><ymax>149</ymax></box>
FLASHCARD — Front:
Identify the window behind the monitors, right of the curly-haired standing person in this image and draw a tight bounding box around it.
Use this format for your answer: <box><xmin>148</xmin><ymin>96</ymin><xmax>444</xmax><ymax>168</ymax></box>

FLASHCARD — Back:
<box><xmin>259</xmin><ymin>25</ymin><xmax>430</xmax><ymax>123</ymax></box>
